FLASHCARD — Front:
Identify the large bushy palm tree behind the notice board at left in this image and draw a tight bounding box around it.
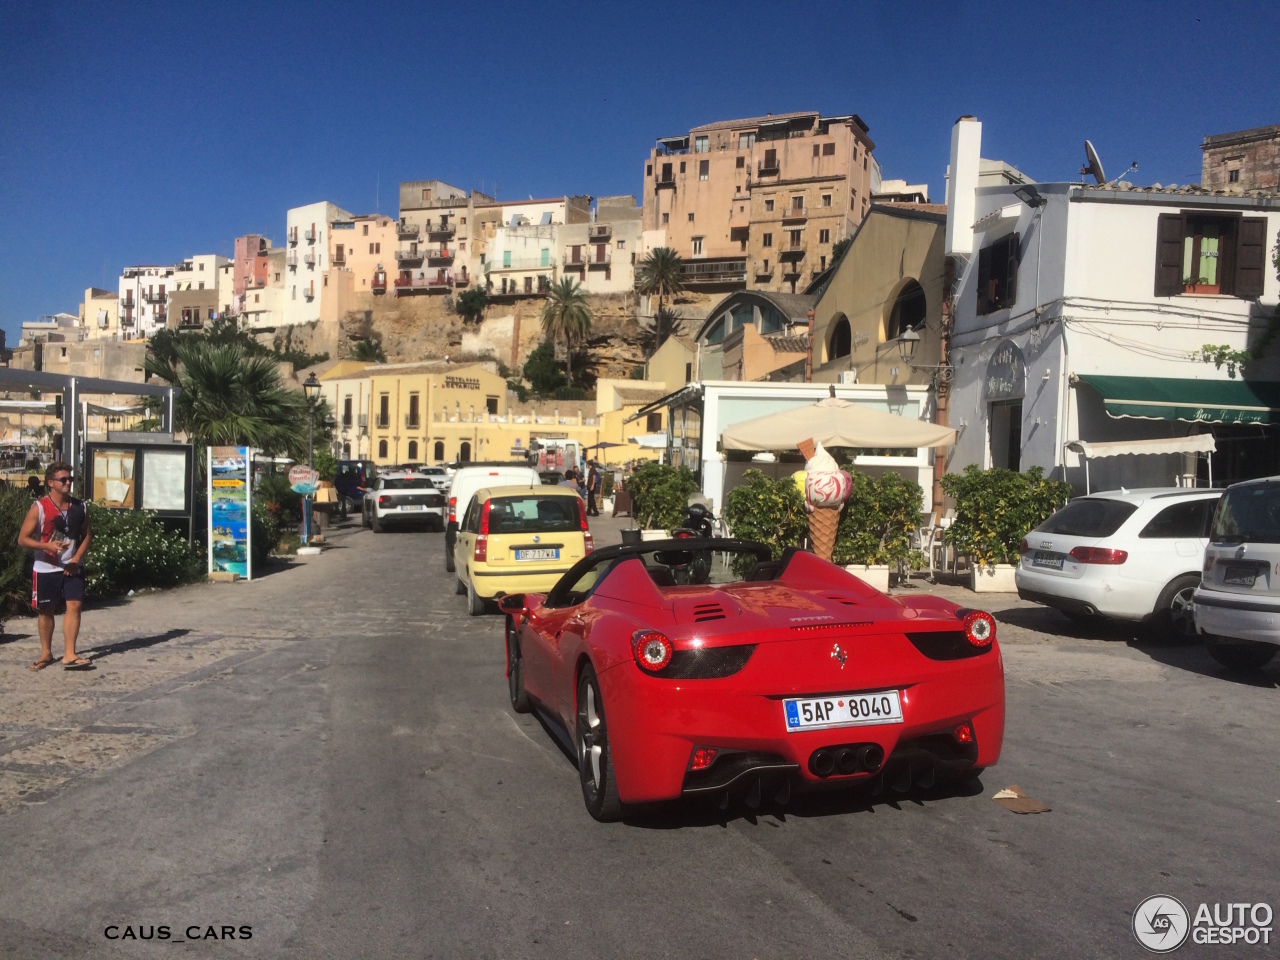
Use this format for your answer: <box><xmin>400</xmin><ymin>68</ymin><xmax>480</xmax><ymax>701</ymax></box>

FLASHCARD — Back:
<box><xmin>146</xmin><ymin>340</ymin><xmax>307</xmax><ymax>456</ymax></box>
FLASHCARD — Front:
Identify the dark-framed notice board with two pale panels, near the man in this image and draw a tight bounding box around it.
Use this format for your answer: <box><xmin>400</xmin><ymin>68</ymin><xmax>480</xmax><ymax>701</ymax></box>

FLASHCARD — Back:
<box><xmin>81</xmin><ymin>440</ymin><xmax>195</xmax><ymax>520</ymax></box>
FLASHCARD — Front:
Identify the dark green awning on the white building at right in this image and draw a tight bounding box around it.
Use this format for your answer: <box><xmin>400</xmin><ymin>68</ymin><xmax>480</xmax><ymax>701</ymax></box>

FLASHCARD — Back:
<box><xmin>1079</xmin><ymin>374</ymin><xmax>1280</xmax><ymax>424</ymax></box>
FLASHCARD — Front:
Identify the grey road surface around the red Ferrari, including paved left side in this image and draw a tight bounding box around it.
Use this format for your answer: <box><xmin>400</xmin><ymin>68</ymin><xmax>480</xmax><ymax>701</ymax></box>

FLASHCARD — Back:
<box><xmin>0</xmin><ymin>524</ymin><xmax>1280</xmax><ymax>960</ymax></box>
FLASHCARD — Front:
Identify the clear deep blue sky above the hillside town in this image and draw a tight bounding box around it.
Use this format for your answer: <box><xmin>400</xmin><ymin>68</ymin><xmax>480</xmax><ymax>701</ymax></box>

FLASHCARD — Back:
<box><xmin>0</xmin><ymin>0</ymin><xmax>1280</xmax><ymax>344</ymax></box>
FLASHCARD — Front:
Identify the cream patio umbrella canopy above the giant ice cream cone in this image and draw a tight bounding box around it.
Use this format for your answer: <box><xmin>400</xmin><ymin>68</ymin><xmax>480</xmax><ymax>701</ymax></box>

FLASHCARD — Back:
<box><xmin>721</xmin><ymin>397</ymin><xmax>956</xmax><ymax>452</ymax></box>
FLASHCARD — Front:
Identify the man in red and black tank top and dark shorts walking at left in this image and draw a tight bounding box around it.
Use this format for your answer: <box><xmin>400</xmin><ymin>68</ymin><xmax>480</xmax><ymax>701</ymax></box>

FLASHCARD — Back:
<box><xmin>18</xmin><ymin>462</ymin><xmax>93</xmax><ymax>669</ymax></box>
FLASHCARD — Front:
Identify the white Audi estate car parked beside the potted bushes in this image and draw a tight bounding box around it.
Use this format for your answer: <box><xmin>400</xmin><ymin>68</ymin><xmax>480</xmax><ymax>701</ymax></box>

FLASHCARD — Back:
<box><xmin>1014</xmin><ymin>486</ymin><xmax>1222</xmax><ymax>640</ymax></box>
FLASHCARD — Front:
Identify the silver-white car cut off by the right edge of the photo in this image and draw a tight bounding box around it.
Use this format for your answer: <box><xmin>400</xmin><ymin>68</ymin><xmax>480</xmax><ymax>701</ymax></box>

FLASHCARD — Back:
<box><xmin>1194</xmin><ymin>476</ymin><xmax>1280</xmax><ymax>669</ymax></box>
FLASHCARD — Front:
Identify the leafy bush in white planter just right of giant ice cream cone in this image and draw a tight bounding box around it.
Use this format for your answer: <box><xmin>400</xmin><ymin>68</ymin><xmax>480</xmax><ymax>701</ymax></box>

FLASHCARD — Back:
<box><xmin>832</xmin><ymin>465</ymin><xmax>924</xmax><ymax>593</ymax></box>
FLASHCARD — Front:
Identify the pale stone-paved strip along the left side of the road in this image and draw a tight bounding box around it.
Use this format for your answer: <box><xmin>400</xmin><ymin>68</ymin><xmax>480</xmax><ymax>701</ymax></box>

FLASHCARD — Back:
<box><xmin>0</xmin><ymin>525</ymin><xmax>356</xmax><ymax>815</ymax></box>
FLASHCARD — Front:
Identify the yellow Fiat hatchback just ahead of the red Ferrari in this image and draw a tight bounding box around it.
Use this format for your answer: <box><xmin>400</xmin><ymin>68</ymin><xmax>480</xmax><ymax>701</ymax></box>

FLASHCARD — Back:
<box><xmin>453</xmin><ymin>486</ymin><xmax>595</xmax><ymax>617</ymax></box>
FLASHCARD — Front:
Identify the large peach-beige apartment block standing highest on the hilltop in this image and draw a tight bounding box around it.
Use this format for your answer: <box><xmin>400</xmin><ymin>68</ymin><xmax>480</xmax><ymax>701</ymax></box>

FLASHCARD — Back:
<box><xmin>643</xmin><ymin>111</ymin><xmax>879</xmax><ymax>293</ymax></box>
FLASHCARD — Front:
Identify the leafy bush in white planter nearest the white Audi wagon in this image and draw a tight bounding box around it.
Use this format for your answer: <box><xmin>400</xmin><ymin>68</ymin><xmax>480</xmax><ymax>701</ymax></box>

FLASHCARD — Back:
<box><xmin>942</xmin><ymin>465</ymin><xmax>1071</xmax><ymax>593</ymax></box>
